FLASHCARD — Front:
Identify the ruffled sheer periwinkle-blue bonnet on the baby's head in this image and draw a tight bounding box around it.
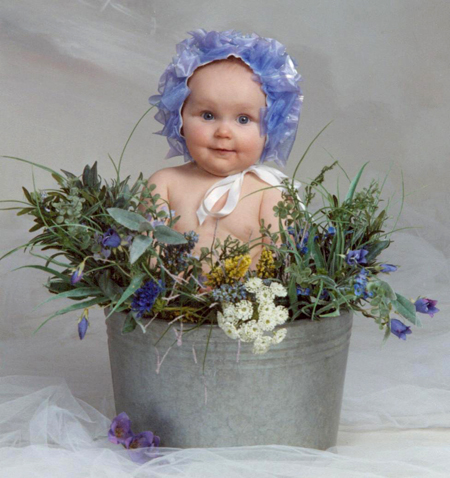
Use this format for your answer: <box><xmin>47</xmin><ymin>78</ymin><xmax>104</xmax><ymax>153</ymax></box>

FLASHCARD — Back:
<box><xmin>149</xmin><ymin>29</ymin><xmax>303</xmax><ymax>167</ymax></box>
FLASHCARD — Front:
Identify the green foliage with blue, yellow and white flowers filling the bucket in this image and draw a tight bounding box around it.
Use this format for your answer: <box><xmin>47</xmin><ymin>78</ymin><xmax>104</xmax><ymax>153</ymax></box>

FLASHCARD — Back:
<box><xmin>0</xmin><ymin>110</ymin><xmax>438</xmax><ymax>354</ymax></box>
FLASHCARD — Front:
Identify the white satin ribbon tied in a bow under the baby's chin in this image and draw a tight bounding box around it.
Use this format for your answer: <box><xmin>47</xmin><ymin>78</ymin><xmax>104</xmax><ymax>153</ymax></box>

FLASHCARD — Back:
<box><xmin>197</xmin><ymin>164</ymin><xmax>304</xmax><ymax>226</ymax></box>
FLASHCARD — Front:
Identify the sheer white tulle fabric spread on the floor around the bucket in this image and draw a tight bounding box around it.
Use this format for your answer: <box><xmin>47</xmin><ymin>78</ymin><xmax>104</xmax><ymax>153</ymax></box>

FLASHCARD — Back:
<box><xmin>0</xmin><ymin>376</ymin><xmax>450</xmax><ymax>478</ymax></box>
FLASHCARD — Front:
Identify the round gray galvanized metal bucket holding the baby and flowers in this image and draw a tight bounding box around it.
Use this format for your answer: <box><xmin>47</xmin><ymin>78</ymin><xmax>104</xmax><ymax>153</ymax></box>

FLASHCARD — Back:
<box><xmin>106</xmin><ymin>312</ymin><xmax>352</xmax><ymax>450</ymax></box>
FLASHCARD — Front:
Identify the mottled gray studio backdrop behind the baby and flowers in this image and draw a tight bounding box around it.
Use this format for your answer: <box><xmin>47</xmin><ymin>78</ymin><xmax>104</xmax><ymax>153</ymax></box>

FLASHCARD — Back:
<box><xmin>0</xmin><ymin>0</ymin><xmax>450</xmax><ymax>418</ymax></box>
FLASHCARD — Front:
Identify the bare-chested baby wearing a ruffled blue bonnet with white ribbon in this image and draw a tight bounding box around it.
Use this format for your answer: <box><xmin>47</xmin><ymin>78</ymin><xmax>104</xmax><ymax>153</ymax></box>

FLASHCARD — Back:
<box><xmin>142</xmin><ymin>30</ymin><xmax>302</xmax><ymax>272</ymax></box>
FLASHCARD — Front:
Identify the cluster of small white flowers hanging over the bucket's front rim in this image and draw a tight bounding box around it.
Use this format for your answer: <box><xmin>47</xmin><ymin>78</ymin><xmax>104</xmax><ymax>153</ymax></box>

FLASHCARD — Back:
<box><xmin>217</xmin><ymin>277</ymin><xmax>289</xmax><ymax>354</ymax></box>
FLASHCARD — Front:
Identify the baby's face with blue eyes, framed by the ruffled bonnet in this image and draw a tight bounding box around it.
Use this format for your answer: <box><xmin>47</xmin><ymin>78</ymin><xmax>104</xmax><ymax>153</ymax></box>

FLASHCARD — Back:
<box><xmin>182</xmin><ymin>61</ymin><xmax>266</xmax><ymax>176</ymax></box>
